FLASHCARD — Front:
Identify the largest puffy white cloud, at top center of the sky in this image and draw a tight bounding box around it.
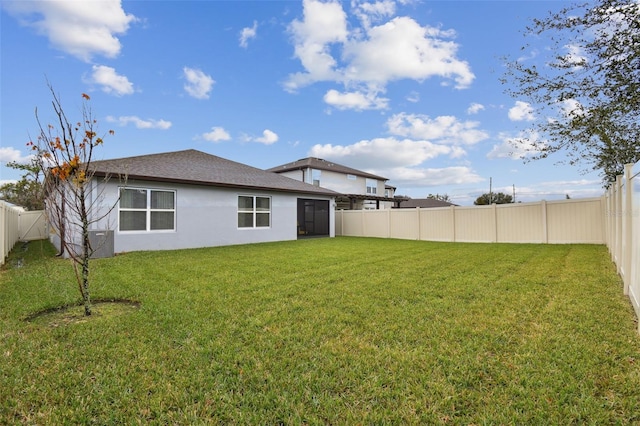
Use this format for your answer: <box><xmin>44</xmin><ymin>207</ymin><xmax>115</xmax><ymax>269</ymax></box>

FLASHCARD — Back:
<box><xmin>285</xmin><ymin>0</ymin><xmax>475</xmax><ymax>100</ymax></box>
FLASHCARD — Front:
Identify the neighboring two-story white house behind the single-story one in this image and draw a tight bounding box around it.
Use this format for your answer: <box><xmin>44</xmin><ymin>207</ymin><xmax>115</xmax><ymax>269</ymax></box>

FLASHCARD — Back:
<box><xmin>267</xmin><ymin>157</ymin><xmax>405</xmax><ymax>210</ymax></box>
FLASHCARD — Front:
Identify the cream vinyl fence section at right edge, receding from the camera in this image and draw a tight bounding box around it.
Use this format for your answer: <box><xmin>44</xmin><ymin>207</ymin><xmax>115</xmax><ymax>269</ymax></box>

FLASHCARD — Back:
<box><xmin>604</xmin><ymin>162</ymin><xmax>640</xmax><ymax>331</ymax></box>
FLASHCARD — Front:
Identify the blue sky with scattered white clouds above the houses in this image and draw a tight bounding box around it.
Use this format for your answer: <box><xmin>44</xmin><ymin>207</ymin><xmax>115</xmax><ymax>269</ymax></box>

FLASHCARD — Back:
<box><xmin>0</xmin><ymin>0</ymin><xmax>602</xmax><ymax>205</ymax></box>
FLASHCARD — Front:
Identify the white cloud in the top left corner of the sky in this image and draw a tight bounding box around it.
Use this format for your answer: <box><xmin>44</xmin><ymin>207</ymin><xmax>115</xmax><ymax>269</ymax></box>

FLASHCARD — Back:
<box><xmin>3</xmin><ymin>0</ymin><xmax>136</xmax><ymax>62</ymax></box>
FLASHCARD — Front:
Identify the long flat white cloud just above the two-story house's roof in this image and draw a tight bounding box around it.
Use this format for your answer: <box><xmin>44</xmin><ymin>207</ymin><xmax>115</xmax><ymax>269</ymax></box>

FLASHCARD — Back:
<box><xmin>309</xmin><ymin>137</ymin><xmax>453</xmax><ymax>170</ymax></box>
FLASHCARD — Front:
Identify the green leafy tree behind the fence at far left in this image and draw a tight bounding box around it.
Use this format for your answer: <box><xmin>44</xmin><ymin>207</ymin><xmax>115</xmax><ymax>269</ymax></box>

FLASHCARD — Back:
<box><xmin>0</xmin><ymin>158</ymin><xmax>44</xmax><ymax>210</ymax></box>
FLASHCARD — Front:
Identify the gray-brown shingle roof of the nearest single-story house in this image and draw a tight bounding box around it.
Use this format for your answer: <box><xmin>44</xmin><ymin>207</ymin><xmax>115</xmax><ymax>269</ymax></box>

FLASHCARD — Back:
<box><xmin>91</xmin><ymin>149</ymin><xmax>338</xmax><ymax>196</ymax></box>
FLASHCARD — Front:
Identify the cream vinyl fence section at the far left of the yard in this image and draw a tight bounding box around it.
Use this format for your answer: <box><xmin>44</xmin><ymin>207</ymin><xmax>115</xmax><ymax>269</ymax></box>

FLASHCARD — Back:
<box><xmin>0</xmin><ymin>201</ymin><xmax>49</xmax><ymax>265</ymax></box>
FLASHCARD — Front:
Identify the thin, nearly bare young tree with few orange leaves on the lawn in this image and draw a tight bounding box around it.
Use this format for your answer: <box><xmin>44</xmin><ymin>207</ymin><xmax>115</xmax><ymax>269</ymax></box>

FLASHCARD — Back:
<box><xmin>27</xmin><ymin>85</ymin><xmax>115</xmax><ymax>316</ymax></box>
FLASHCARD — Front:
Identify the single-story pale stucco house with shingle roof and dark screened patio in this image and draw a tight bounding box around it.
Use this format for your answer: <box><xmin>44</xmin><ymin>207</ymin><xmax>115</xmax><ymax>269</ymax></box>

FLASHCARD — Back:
<box><xmin>53</xmin><ymin>150</ymin><xmax>338</xmax><ymax>253</ymax></box>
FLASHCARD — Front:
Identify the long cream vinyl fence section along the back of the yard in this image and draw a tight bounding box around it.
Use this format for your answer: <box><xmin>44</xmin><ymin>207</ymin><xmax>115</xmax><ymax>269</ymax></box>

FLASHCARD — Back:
<box><xmin>336</xmin><ymin>198</ymin><xmax>606</xmax><ymax>244</ymax></box>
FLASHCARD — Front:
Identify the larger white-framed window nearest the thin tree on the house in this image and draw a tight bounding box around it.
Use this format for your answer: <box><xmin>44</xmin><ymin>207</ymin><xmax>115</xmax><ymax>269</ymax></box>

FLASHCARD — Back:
<box><xmin>119</xmin><ymin>188</ymin><xmax>176</xmax><ymax>231</ymax></box>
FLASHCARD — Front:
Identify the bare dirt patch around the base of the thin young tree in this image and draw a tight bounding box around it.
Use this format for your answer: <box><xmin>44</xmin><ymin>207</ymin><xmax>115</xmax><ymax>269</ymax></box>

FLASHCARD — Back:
<box><xmin>25</xmin><ymin>299</ymin><xmax>140</xmax><ymax>327</ymax></box>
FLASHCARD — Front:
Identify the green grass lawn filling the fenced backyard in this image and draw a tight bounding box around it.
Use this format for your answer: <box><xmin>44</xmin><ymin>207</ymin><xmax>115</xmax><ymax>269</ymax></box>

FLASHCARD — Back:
<box><xmin>0</xmin><ymin>237</ymin><xmax>640</xmax><ymax>424</ymax></box>
